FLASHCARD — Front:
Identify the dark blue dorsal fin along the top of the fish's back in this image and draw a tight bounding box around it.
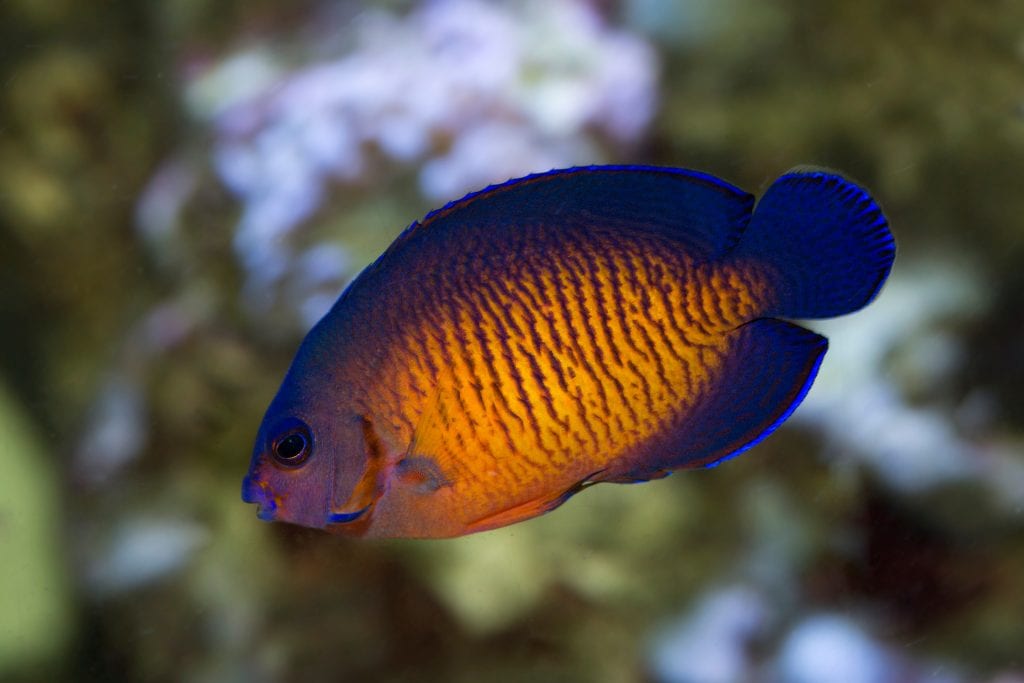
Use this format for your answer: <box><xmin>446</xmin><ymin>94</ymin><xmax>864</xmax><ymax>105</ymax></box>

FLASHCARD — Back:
<box><xmin>381</xmin><ymin>166</ymin><xmax>754</xmax><ymax>260</ymax></box>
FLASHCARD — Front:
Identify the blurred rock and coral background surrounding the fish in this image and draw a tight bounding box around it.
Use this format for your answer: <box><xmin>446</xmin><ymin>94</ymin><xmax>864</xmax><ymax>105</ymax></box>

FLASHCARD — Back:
<box><xmin>0</xmin><ymin>0</ymin><xmax>1024</xmax><ymax>683</ymax></box>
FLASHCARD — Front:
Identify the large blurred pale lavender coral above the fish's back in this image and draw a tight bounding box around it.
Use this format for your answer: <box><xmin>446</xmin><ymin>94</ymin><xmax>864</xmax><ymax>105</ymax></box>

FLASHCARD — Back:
<box><xmin>147</xmin><ymin>0</ymin><xmax>657</xmax><ymax>327</ymax></box>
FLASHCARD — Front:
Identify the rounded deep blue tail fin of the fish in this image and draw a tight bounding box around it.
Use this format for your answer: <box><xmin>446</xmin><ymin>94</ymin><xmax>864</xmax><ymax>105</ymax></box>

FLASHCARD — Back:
<box><xmin>735</xmin><ymin>169</ymin><xmax>896</xmax><ymax>318</ymax></box>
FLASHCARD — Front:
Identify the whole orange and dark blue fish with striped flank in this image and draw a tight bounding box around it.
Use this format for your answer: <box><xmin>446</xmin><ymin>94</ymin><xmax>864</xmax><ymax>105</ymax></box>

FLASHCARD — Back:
<box><xmin>242</xmin><ymin>166</ymin><xmax>896</xmax><ymax>539</ymax></box>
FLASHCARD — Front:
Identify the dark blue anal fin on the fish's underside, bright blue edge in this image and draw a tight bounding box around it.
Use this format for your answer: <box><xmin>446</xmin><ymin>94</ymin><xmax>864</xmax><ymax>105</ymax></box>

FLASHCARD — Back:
<box><xmin>611</xmin><ymin>318</ymin><xmax>828</xmax><ymax>481</ymax></box>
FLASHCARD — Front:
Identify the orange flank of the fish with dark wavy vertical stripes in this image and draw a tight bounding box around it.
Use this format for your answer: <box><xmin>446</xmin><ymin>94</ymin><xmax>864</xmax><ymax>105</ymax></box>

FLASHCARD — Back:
<box><xmin>372</xmin><ymin>225</ymin><xmax>767</xmax><ymax>528</ymax></box>
